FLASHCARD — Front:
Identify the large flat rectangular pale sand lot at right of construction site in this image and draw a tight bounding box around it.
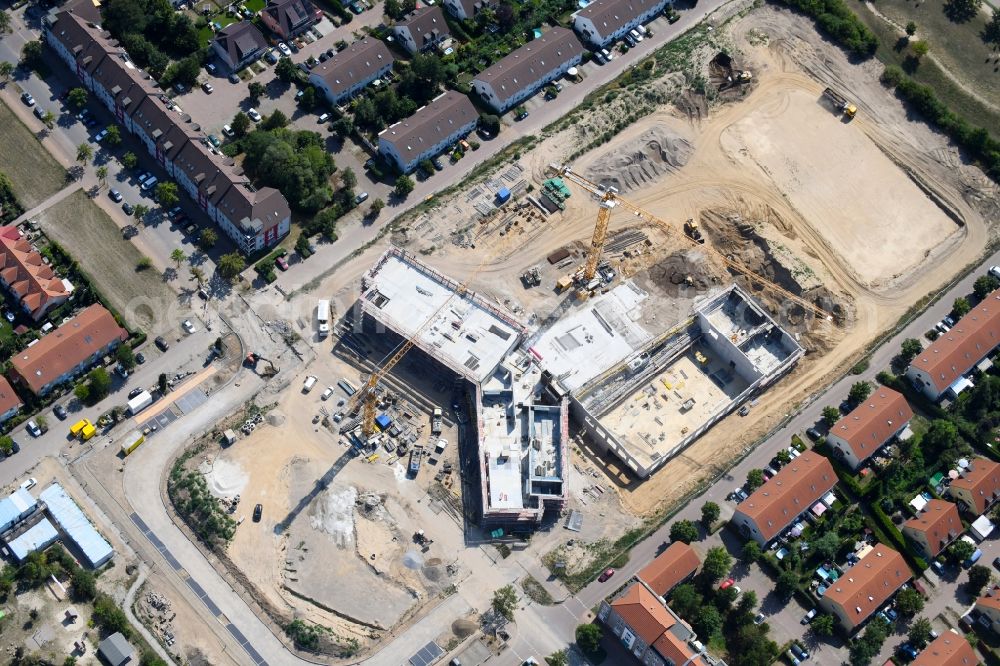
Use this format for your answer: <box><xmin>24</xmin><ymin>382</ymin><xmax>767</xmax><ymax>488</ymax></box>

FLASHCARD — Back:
<box><xmin>722</xmin><ymin>90</ymin><xmax>958</xmax><ymax>286</ymax></box>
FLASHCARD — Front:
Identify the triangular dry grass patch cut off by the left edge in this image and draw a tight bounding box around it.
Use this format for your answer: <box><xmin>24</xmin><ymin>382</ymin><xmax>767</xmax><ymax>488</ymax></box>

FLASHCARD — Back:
<box><xmin>0</xmin><ymin>96</ymin><xmax>66</xmax><ymax>210</ymax></box>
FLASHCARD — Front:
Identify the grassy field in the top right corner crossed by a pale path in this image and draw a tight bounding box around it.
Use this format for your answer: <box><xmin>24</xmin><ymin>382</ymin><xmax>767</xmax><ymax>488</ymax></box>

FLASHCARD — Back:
<box><xmin>855</xmin><ymin>0</ymin><xmax>1000</xmax><ymax>136</ymax></box>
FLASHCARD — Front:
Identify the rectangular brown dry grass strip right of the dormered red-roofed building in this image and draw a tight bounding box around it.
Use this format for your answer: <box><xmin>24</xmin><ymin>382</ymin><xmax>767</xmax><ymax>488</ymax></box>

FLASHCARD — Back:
<box><xmin>39</xmin><ymin>192</ymin><xmax>177</xmax><ymax>332</ymax></box>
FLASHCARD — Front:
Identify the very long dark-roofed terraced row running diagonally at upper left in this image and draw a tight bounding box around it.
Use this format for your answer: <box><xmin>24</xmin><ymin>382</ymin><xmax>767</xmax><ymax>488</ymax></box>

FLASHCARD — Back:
<box><xmin>44</xmin><ymin>9</ymin><xmax>291</xmax><ymax>254</ymax></box>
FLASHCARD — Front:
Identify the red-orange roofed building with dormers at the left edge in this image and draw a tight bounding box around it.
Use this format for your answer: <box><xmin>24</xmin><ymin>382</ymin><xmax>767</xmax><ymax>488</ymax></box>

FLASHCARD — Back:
<box><xmin>0</xmin><ymin>227</ymin><xmax>73</xmax><ymax>321</ymax></box>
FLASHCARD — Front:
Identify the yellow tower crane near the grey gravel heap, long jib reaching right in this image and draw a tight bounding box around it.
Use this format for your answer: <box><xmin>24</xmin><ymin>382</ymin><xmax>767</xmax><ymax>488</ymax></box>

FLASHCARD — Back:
<box><xmin>549</xmin><ymin>164</ymin><xmax>833</xmax><ymax>321</ymax></box>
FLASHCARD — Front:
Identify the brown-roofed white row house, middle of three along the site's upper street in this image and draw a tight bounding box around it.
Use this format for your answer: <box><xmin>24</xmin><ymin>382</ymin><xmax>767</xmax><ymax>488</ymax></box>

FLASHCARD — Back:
<box><xmin>472</xmin><ymin>27</ymin><xmax>583</xmax><ymax>113</ymax></box>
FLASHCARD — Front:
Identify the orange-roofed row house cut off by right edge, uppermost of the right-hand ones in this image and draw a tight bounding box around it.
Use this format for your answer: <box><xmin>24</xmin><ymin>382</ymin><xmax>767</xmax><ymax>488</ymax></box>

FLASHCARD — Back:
<box><xmin>906</xmin><ymin>289</ymin><xmax>1000</xmax><ymax>400</ymax></box>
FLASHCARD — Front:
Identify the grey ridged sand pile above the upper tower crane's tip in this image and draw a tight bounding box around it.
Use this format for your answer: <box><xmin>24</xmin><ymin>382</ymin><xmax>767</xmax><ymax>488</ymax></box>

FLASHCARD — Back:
<box><xmin>585</xmin><ymin>125</ymin><xmax>694</xmax><ymax>192</ymax></box>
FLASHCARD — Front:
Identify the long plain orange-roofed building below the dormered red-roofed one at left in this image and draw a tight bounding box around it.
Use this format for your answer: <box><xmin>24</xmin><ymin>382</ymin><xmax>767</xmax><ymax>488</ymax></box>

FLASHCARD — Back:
<box><xmin>10</xmin><ymin>304</ymin><xmax>128</xmax><ymax>395</ymax></box>
